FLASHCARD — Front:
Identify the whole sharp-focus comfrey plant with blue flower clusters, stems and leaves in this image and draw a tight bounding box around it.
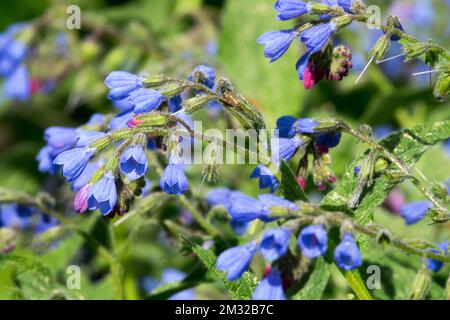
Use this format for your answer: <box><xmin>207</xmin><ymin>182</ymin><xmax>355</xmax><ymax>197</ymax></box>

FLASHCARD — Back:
<box><xmin>0</xmin><ymin>0</ymin><xmax>450</xmax><ymax>300</ymax></box>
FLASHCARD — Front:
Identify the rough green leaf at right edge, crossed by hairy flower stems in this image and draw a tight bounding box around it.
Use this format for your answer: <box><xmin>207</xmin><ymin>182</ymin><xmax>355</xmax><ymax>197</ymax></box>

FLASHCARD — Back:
<box><xmin>321</xmin><ymin>121</ymin><xmax>450</xmax><ymax>224</ymax></box>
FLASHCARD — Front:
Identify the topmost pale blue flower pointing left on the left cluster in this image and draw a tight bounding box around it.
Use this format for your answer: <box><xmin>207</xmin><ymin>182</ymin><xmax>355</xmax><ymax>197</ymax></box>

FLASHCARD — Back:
<box><xmin>105</xmin><ymin>71</ymin><xmax>143</xmax><ymax>100</ymax></box>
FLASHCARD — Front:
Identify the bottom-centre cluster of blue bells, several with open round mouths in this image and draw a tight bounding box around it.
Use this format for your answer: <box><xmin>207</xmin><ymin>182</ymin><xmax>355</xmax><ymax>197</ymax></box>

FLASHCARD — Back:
<box><xmin>212</xmin><ymin>188</ymin><xmax>362</xmax><ymax>300</ymax></box>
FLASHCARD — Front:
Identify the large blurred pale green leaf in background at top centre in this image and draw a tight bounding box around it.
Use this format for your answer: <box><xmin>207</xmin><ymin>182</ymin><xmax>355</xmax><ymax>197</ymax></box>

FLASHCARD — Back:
<box><xmin>219</xmin><ymin>0</ymin><xmax>305</xmax><ymax>126</ymax></box>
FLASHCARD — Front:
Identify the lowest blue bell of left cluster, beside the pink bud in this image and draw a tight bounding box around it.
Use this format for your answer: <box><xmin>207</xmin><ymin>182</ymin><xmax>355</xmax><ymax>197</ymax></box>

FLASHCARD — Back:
<box><xmin>88</xmin><ymin>171</ymin><xmax>117</xmax><ymax>215</ymax></box>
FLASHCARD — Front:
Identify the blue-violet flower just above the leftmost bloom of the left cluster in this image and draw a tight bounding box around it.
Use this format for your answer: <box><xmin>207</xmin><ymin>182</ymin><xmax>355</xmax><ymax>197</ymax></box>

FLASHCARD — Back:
<box><xmin>44</xmin><ymin>127</ymin><xmax>78</xmax><ymax>157</ymax></box>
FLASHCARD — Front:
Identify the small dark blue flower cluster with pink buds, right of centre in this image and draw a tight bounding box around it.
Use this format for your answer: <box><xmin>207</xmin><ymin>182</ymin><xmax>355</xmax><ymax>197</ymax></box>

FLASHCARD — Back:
<box><xmin>251</xmin><ymin>116</ymin><xmax>342</xmax><ymax>193</ymax></box>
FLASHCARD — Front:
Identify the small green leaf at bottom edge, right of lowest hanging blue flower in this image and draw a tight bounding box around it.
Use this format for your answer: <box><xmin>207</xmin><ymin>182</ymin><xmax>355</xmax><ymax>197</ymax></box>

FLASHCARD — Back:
<box><xmin>292</xmin><ymin>258</ymin><xmax>331</xmax><ymax>300</ymax></box>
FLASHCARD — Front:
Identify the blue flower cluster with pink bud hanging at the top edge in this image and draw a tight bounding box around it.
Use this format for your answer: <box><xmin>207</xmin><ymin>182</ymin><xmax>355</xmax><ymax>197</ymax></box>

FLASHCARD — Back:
<box><xmin>257</xmin><ymin>0</ymin><xmax>364</xmax><ymax>89</ymax></box>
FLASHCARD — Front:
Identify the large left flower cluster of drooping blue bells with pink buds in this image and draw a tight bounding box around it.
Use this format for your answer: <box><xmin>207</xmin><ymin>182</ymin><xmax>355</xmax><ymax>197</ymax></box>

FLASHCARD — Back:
<box><xmin>37</xmin><ymin>66</ymin><xmax>229</xmax><ymax>217</ymax></box>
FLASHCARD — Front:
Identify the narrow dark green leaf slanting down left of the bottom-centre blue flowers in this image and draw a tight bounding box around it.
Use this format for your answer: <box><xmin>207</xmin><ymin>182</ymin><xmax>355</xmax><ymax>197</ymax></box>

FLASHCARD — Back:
<box><xmin>181</xmin><ymin>237</ymin><xmax>258</xmax><ymax>300</ymax></box>
